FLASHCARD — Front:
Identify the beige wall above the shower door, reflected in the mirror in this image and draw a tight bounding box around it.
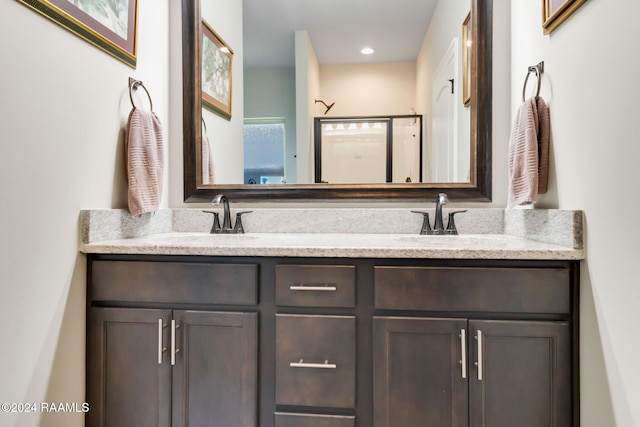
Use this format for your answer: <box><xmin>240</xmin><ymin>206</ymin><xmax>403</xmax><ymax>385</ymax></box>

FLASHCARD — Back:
<box><xmin>314</xmin><ymin>62</ymin><xmax>416</xmax><ymax>116</ymax></box>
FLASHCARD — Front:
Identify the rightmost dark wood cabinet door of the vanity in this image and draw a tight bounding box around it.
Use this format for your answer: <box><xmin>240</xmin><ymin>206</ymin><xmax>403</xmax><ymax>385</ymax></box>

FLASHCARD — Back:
<box><xmin>469</xmin><ymin>320</ymin><xmax>571</xmax><ymax>427</ymax></box>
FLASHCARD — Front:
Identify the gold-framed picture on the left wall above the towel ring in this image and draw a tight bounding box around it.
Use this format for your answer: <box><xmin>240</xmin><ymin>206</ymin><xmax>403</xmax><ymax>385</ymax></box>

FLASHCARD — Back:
<box><xmin>18</xmin><ymin>0</ymin><xmax>138</xmax><ymax>68</ymax></box>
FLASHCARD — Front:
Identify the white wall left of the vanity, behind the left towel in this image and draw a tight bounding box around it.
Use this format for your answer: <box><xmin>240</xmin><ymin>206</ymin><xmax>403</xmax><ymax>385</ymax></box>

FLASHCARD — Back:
<box><xmin>0</xmin><ymin>0</ymin><xmax>170</xmax><ymax>427</ymax></box>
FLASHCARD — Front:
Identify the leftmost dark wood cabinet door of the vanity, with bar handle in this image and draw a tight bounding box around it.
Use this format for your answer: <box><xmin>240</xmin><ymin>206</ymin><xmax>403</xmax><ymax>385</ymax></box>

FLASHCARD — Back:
<box><xmin>86</xmin><ymin>308</ymin><xmax>171</xmax><ymax>427</ymax></box>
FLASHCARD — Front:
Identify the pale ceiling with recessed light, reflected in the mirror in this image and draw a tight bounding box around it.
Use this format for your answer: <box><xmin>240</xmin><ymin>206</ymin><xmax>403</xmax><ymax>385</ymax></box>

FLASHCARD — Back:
<box><xmin>243</xmin><ymin>0</ymin><xmax>438</xmax><ymax>68</ymax></box>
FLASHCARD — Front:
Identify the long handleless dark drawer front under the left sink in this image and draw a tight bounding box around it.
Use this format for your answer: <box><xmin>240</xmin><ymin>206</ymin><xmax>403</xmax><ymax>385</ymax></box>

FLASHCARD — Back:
<box><xmin>90</xmin><ymin>261</ymin><xmax>258</xmax><ymax>305</ymax></box>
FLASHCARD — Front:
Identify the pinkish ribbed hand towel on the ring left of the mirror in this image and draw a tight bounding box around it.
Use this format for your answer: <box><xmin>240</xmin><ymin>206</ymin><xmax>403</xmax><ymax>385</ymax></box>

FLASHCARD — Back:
<box><xmin>125</xmin><ymin>107</ymin><xmax>164</xmax><ymax>218</ymax></box>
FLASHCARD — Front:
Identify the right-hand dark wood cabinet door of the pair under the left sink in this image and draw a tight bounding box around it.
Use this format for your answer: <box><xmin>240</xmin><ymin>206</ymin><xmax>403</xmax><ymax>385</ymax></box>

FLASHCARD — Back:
<box><xmin>172</xmin><ymin>311</ymin><xmax>258</xmax><ymax>427</ymax></box>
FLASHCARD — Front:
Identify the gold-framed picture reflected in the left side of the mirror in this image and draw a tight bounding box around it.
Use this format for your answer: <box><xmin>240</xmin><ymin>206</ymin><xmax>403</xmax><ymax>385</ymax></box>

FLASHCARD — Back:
<box><xmin>202</xmin><ymin>20</ymin><xmax>233</xmax><ymax>120</ymax></box>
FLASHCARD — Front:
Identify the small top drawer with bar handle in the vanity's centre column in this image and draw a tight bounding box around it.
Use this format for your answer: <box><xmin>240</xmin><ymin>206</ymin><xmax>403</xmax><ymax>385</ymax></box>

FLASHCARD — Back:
<box><xmin>276</xmin><ymin>265</ymin><xmax>356</xmax><ymax>307</ymax></box>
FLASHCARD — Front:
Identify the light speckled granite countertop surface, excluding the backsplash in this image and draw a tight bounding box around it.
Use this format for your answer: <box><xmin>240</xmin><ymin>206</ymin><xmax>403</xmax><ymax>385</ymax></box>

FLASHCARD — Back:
<box><xmin>82</xmin><ymin>232</ymin><xmax>582</xmax><ymax>260</ymax></box>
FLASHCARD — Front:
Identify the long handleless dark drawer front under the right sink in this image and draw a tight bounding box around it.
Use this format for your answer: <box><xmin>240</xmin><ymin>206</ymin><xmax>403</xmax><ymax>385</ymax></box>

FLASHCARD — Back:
<box><xmin>375</xmin><ymin>266</ymin><xmax>571</xmax><ymax>314</ymax></box>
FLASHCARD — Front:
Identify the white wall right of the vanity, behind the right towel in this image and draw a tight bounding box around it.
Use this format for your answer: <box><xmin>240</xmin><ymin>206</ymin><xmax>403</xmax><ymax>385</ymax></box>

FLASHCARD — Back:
<box><xmin>510</xmin><ymin>0</ymin><xmax>640</xmax><ymax>427</ymax></box>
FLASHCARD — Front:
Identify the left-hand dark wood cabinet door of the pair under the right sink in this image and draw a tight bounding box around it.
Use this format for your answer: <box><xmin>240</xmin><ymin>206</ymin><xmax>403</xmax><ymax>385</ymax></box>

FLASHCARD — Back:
<box><xmin>373</xmin><ymin>317</ymin><xmax>468</xmax><ymax>427</ymax></box>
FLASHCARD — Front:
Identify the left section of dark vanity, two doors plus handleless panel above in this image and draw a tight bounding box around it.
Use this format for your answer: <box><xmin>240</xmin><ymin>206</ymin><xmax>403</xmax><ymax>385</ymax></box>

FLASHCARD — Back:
<box><xmin>86</xmin><ymin>260</ymin><xmax>258</xmax><ymax>427</ymax></box>
